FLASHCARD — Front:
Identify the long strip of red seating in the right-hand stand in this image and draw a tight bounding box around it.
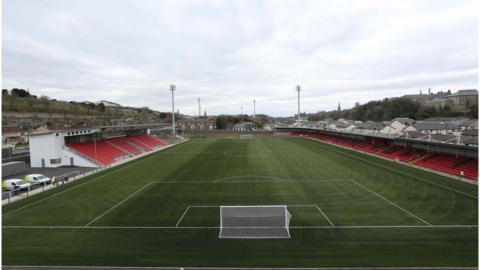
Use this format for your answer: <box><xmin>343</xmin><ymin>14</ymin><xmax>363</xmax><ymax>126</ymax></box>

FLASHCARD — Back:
<box><xmin>290</xmin><ymin>131</ymin><xmax>478</xmax><ymax>180</ymax></box>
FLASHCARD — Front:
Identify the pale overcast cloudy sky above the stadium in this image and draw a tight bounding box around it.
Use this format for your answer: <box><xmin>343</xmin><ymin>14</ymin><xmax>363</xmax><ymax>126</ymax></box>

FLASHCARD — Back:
<box><xmin>2</xmin><ymin>0</ymin><xmax>478</xmax><ymax>116</ymax></box>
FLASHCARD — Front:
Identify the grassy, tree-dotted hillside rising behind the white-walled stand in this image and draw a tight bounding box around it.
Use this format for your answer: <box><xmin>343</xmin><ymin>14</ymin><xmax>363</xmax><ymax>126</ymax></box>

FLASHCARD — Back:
<box><xmin>2</xmin><ymin>88</ymin><xmax>174</xmax><ymax>130</ymax></box>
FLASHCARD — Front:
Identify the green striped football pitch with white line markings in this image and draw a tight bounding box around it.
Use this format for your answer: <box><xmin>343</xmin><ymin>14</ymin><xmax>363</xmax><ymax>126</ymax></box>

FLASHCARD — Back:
<box><xmin>2</xmin><ymin>135</ymin><xmax>478</xmax><ymax>267</ymax></box>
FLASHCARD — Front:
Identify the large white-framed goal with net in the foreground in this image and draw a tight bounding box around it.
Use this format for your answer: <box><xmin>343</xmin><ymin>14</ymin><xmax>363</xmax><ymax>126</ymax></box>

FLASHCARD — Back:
<box><xmin>219</xmin><ymin>205</ymin><xmax>292</xmax><ymax>238</ymax></box>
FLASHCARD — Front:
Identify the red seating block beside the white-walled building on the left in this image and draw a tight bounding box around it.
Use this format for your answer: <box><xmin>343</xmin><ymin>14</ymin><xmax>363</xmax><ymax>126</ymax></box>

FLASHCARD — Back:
<box><xmin>68</xmin><ymin>134</ymin><xmax>167</xmax><ymax>165</ymax></box>
